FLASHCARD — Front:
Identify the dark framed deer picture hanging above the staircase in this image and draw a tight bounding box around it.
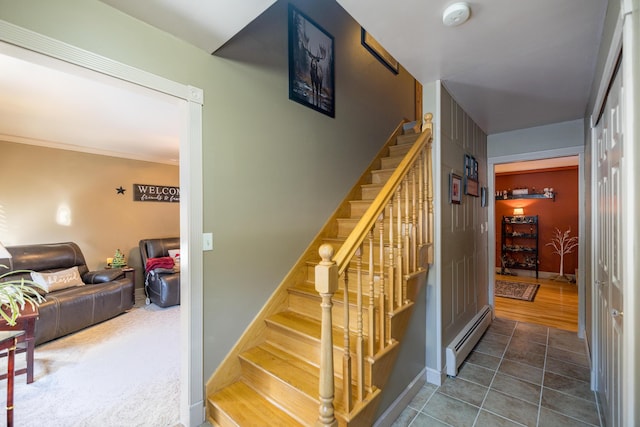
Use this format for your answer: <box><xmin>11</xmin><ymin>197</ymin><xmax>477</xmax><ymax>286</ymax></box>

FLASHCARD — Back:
<box><xmin>289</xmin><ymin>4</ymin><xmax>335</xmax><ymax>117</ymax></box>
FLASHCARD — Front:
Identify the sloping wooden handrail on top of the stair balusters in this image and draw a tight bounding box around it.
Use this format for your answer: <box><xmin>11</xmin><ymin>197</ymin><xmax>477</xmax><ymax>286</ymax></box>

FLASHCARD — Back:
<box><xmin>333</xmin><ymin>113</ymin><xmax>433</xmax><ymax>275</ymax></box>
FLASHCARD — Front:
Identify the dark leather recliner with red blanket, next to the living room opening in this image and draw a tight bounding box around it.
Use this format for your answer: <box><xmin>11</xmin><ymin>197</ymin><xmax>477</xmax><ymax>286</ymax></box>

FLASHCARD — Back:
<box><xmin>139</xmin><ymin>237</ymin><xmax>180</xmax><ymax>307</ymax></box>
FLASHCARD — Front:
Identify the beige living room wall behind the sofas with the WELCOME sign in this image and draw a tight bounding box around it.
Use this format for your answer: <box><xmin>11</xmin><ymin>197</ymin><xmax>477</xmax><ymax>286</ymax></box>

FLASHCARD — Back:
<box><xmin>0</xmin><ymin>141</ymin><xmax>180</xmax><ymax>287</ymax></box>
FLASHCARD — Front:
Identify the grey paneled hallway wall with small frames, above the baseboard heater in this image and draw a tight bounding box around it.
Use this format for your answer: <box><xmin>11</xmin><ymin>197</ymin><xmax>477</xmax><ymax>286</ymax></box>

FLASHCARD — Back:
<box><xmin>436</xmin><ymin>85</ymin><xmax>488</xmax><ymax>372</ymax></box>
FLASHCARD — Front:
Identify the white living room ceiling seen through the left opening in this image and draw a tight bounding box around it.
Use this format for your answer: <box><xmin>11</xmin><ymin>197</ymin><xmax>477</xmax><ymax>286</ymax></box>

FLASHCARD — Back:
<box><xmin>0</xmin><ymin>43</ymin><xmax>182</xmax><ymax>165</ymax></box>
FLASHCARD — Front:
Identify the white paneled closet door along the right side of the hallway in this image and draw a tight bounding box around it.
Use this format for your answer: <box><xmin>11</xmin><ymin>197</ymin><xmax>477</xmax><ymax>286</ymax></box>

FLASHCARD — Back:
<box><xmin>592</xmin><ymin>58</ymin><xmax>624</xmax><ymax>426</ymax></box>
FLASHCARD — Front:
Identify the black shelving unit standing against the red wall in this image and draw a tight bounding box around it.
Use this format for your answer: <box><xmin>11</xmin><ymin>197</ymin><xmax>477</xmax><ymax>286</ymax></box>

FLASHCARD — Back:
<box><xmin>501</xmin><ymin>215</ymin><xmax>538</xmax><ymax>279</ymax></box>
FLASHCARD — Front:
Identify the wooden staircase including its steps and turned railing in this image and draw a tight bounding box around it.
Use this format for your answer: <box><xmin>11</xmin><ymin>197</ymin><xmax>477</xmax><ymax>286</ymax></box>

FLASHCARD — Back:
<box><xmin>206</xmin><ymin>114</ymin><xmax>433</xmax><ymax>426</ymax></box>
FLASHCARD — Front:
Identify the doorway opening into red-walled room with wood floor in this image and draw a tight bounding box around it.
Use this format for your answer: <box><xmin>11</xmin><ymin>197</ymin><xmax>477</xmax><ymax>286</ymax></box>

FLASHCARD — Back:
<box><xmin>488</xmin><ymin>147</ymin><xmax>584</xmax><ymax>337</ymax></box>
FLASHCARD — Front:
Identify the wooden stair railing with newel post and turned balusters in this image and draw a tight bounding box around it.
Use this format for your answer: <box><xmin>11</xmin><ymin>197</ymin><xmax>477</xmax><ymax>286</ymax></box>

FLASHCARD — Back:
<box><xmin>315</xmin><ymin>113</ymin><xmax>433</xmax><ymax>427</ymax></box>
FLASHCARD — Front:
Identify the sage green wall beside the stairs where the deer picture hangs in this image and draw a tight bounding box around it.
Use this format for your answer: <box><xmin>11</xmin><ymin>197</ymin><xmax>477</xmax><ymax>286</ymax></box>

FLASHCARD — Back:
<box><xmin>0</xmin><ymin>0</ymin><xmax>414</xmax><ymax>402</ymax></box>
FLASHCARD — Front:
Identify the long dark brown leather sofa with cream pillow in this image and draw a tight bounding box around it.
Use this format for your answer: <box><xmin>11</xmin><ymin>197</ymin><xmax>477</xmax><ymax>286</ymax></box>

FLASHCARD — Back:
<box><xmin>1</xmin><ymin>242</ymin><xmax>134</xmax><ymax>345</ymax></box>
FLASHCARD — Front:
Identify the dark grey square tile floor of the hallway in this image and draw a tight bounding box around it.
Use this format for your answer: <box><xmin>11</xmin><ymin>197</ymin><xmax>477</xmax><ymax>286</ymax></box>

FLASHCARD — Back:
<box><xmin>393</xmin><ymin>319</ymin><xmax>601</xmax><ymax>427</ymax></box>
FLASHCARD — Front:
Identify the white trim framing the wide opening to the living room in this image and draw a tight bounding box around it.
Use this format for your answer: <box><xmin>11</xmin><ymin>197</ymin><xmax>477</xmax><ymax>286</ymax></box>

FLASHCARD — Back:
<box><xmin>0</xmin><ymin>21</ymin><xmax>204</xmax><ymax>426</ymax></box>
